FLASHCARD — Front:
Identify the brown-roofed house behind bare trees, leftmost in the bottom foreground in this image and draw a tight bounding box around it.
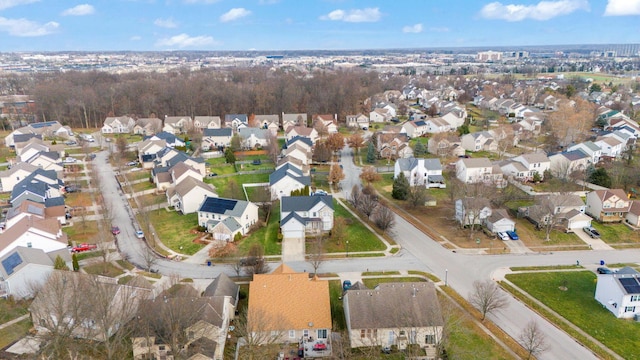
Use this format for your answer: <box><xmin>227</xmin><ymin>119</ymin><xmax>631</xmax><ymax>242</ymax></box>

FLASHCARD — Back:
<box><xmin>29</xmin><ymin>270</ymin><xmax>151</xmax><ymax>341</ymax></box>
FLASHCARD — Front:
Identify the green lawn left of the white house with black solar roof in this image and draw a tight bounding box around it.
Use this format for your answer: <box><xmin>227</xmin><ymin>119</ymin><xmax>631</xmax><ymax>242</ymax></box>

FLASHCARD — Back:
<box><xmin>149</xmin><ymin>209</ymin><xmax>204</xmax><ymax>255</ymax></box>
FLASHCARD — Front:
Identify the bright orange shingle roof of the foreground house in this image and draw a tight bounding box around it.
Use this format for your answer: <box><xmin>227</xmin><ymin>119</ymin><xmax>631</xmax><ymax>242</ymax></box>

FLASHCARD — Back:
<box><xmin>248</xmin><ymin>264</ymin><xmax>332</xmax><ymax>331</ymax></box>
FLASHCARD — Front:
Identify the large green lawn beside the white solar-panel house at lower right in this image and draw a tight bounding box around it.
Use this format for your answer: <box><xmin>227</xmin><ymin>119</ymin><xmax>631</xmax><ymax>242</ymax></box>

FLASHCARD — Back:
<box><xmin>507</xmin><ymin>271</ymin><xmax>640</xmax><ymax>359</ymax></box>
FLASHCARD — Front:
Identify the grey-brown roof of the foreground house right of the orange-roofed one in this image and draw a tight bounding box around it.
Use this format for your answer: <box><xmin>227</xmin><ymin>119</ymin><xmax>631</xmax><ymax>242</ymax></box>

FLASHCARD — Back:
<box><xmin>344</xmin><ymin>282</ymin><xmax>444</xmax><ymax>329</ymax></box>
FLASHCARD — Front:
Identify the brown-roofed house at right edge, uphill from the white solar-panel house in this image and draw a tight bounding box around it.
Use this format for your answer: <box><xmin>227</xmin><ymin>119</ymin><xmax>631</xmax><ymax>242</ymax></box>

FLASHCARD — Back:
<box><xmin>586</xmin><ymin>189</ymin><xmax>631</xmax><ymax>223</ymax></box>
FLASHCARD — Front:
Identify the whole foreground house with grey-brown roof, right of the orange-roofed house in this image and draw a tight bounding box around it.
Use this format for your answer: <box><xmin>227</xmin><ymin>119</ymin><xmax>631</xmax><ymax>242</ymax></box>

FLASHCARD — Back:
<box><xmin>342</xmin><ymin>282</ymin><xmax>444</xmax><ymax>359</ymax></box>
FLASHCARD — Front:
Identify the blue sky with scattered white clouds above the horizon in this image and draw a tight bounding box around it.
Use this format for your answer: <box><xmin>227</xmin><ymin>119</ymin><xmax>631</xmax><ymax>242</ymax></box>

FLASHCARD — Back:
<box><xmin>0</xmin><ymin>0</ymin><xmax>640</xmax><ymax>52</ymax></box>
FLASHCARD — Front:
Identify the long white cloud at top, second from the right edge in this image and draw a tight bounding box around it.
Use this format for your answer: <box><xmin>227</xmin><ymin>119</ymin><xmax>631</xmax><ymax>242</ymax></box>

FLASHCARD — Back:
<box><xmin>480</xmin><ymin>0</ymin><xmax>589</xmax><ymax>21</ymax></box>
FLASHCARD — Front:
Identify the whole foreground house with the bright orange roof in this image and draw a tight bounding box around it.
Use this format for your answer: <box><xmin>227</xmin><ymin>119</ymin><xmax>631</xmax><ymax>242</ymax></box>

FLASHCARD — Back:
<box><xmin>247</xmin><ymin>264</ymin><xmax>332</xmax><ymax>352</ymax></box>
